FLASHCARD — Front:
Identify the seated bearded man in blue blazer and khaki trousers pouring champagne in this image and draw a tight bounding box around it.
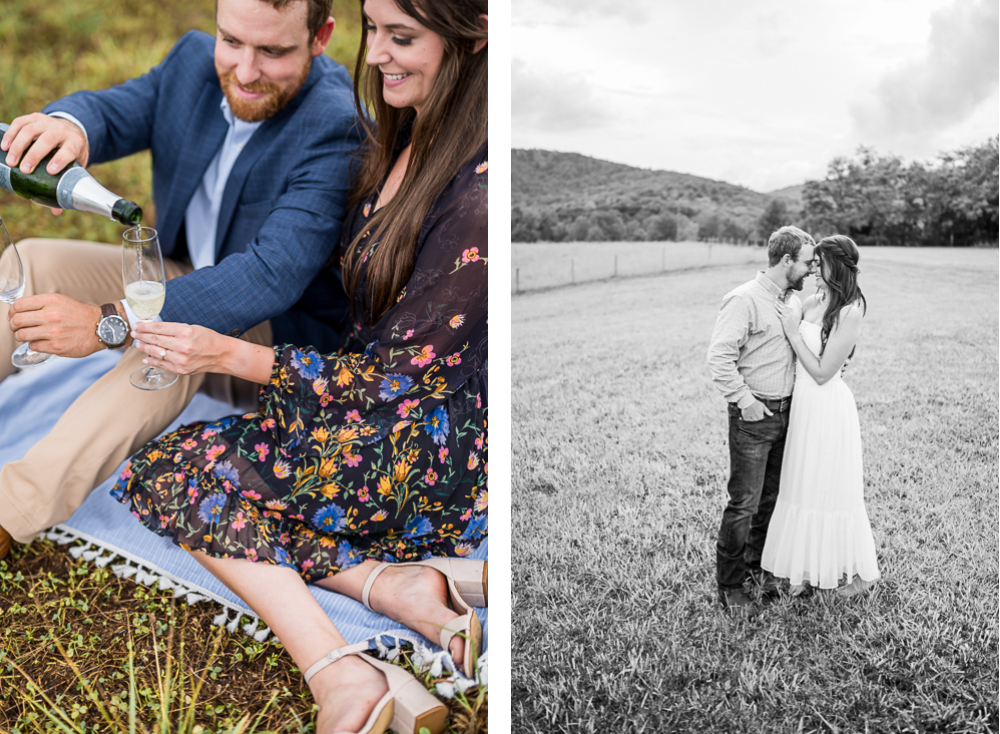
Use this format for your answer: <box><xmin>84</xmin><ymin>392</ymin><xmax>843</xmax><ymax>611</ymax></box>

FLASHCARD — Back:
<box><xmin>0</xmin><ymin>0</ymin><xmax>359</xmax><ymax>558</ymax></box>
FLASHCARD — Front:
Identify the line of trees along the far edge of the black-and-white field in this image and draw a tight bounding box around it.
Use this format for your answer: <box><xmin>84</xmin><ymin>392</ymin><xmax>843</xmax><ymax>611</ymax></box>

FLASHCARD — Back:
<box><xmin>511</xmin><ymin>137</ymin><xmax>1000</xmax><ymax>247</ymax></box>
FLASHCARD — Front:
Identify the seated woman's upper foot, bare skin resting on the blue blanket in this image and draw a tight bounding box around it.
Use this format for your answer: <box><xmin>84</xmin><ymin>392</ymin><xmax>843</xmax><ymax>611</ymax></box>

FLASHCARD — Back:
<box><xmin>368</xmin><ymin>565</ymin><xmax>470</xmax><ymax>673</ymax></box>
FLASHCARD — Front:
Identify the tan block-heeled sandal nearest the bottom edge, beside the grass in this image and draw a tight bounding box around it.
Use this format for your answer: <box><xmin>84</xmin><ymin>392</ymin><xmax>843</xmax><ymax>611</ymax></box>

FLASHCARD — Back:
<box><xmin>304</xmin><ymin>641</ymin><xmax>448</xmax><ymax>734</ymax></box>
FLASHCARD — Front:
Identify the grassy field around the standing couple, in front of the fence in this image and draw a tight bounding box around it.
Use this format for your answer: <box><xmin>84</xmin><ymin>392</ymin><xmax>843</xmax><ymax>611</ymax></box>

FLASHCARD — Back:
<box><xmin>512</xmin><ymin>244</ymin><xmax>998</xmax><ymax>733</ymax></box>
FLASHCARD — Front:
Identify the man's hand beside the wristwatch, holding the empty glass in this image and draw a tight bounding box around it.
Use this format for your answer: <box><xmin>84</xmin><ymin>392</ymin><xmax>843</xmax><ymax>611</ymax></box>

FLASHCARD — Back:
<box><xmin>7</xmin><ymin>293</ymin><xmax>104</xmax><ymax>357</ymax></box>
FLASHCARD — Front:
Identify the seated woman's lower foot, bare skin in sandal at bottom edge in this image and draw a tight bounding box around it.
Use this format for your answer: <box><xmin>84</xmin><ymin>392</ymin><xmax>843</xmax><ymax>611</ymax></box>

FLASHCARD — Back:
<box><xmin>309</xmin><ymin>656</ymin><xmax>389</xmax><ymax>734</ymax></box>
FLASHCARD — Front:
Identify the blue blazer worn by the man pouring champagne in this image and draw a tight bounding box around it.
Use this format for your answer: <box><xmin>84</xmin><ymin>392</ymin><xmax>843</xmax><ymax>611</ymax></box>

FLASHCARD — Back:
<box><xmin>43</xmin><ymin>31</ymin><xmax>360</xmax><ymax>351</ymax></box>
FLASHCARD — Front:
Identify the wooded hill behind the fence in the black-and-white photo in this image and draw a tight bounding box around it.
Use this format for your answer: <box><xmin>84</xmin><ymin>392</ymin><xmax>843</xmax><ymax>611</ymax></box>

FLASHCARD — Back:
<box><xmin>511</xmin><ymin>149</ymin><xmax>801</xmax><ymax>242</ymax></box>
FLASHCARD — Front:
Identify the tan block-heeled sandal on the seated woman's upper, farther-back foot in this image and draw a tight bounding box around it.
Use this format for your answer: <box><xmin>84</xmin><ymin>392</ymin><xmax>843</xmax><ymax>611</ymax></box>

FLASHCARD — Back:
<box><xmin>361</xmin><ymin>557</ymin><xmax>489</xmax><ymax>678</ymax></box>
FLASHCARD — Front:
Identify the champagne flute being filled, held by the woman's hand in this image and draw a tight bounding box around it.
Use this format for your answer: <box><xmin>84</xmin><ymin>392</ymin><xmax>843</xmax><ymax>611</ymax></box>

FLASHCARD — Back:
<box><xmin>122</xmin><ymin>227</ymin><xmax>177</xmax><ymax>390</ymax></box>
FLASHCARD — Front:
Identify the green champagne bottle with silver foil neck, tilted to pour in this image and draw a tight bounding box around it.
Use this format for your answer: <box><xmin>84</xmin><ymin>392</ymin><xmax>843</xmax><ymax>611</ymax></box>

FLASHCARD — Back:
<box><xmin>0</xmin><ymin>122</ymin><xmax>142</xmax><ymax>227</ymax></box>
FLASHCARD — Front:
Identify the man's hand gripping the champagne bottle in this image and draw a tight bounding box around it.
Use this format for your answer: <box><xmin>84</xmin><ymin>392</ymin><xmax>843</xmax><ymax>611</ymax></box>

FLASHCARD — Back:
<box><xmin>0</xmin><ymin>112</ymin><xmax>90</xmax><ymax>214</ymax></box>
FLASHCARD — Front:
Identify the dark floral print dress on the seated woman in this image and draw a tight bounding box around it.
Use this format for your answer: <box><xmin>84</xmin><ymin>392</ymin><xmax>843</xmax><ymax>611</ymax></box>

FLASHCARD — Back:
<box><xmin>112</xmin><ymin>146</ymin><xmax>488</xmax><ymax>581</ymax></box>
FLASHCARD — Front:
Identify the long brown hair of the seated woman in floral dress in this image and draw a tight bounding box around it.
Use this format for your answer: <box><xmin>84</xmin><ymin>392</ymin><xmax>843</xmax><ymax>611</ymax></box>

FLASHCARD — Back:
<box><xmin>343</xmin><ymin>0</ymin><xmax>489</xmax><ymax>325</ymax></box>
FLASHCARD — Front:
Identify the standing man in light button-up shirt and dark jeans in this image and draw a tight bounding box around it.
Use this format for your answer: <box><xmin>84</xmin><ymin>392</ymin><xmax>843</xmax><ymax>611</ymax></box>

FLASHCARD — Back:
<box><xmin>708</xmin><ymin>227</ymin><xmax>816</xmax><ymax>612</ymax></box>
